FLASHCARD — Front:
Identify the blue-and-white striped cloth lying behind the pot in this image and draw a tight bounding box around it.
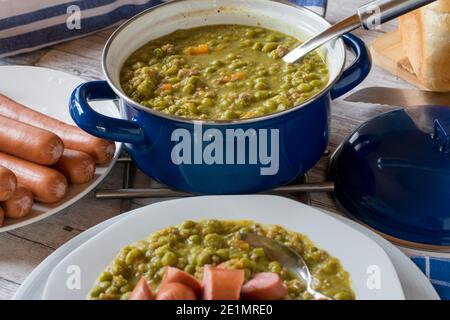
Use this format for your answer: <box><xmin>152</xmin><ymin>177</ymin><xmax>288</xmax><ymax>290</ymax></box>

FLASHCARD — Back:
<box><xmin>0</xmin><ymin>0</ymin><xmax>327</xmax><ymax>57</ymax></box>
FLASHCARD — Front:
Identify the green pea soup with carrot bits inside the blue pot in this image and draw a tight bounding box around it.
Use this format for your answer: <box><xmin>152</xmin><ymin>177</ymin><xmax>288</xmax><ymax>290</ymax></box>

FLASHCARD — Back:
<box><xmin>120</xmin><ymin>25</ymin><xmax>328</xmax><ymax>120</ymax></box>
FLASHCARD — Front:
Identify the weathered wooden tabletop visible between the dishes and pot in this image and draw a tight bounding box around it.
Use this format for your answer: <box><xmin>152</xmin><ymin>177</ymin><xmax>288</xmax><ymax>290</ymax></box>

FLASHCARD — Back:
<box><xmin>0</xmin><ymin>0</ymin><xmax>409</xmax><ymax>299</ymax></box>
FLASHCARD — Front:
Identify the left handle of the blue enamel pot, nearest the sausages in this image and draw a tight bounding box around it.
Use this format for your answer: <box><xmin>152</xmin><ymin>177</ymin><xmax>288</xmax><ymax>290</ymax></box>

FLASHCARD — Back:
<box><xmin>69</xmin><ymin>81</ymin><xmax>147</xmax><ymax>144</ymax></box>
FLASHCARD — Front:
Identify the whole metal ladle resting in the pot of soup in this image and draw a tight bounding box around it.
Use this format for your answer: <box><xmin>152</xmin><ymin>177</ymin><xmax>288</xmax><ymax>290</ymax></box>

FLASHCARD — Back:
<box><xmin>283</xmin><ymin>0</ymin><xmax>436</xmax><ymax>63</ymax></box>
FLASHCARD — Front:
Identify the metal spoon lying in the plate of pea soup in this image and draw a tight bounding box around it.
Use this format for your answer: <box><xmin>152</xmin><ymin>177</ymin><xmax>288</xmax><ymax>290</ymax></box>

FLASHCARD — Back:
<box><xmin>241</xmin><ymin>233</ymin><xmax>332</xmax><ymax>300</ymax></box>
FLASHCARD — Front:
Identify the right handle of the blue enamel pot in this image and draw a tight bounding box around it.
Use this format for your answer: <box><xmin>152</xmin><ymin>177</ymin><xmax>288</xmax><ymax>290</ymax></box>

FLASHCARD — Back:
<box><xmin>330</xmin><ymin>33</ymin><xmax>372</xmax><ymax>100</ymax></box>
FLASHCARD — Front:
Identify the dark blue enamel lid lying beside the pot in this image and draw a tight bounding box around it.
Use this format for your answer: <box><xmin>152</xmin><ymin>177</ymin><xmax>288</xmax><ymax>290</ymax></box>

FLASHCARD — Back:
<box><xmin>330</xmin><ymin>106</ymin><xmax>450</xmax><ymax>247</ymax></box>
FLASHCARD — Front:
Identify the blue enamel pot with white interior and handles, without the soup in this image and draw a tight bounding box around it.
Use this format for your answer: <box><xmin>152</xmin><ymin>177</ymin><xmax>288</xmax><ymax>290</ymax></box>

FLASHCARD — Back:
<box><xmin>70</xmin><ymin>0</ymin><xmax>371</xmax><ymax>194</ymax></box>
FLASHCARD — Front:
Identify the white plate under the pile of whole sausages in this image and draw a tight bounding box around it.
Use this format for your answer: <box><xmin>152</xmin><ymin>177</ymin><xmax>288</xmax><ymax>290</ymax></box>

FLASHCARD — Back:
<box><xmin>0</xmin><ymin>66</ymin><xmax>121</xmax><ymax>232</ymax></box>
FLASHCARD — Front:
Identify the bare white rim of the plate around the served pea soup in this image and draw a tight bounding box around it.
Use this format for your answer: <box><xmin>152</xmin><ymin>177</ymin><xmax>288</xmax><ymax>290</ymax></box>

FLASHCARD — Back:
<box><xmin>43</xmin><ymin>195</ymin><xmax>404</xmax><ymax>300</ymax></box>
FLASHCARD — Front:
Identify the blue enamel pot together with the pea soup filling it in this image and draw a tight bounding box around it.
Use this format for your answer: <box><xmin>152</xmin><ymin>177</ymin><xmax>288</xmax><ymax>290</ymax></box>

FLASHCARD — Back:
<box><xmin>70</xmin><ymin>0</ymin><xmax>371</xmax><ymax>194</ymax></box>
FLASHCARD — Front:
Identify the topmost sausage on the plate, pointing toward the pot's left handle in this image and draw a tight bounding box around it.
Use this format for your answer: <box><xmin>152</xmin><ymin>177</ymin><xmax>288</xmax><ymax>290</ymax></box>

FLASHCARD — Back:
<box><xmin>0</xmin><ymin>94</ymin><xmax>116</xmax><ymax>164</ymax></box>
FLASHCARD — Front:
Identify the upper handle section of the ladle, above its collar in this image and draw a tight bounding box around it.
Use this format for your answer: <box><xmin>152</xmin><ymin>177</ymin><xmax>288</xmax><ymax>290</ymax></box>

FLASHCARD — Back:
<box><xmin>358</xmin><ymin>0</ymin><xmax>436</xmax><ymax>30</ymax></box>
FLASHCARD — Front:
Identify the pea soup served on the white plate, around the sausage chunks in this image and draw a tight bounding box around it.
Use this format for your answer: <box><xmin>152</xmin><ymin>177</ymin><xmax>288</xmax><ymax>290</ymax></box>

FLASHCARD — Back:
<box><xmin>88</xmin><ymin>220</ymin><xmax>355</xmax><ymax>300</ymax></box>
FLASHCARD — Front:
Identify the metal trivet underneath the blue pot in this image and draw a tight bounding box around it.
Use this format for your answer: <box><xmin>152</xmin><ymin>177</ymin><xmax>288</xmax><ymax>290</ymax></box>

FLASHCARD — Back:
<box><xmin>95</xmin><ymin>154</ymin><xmax>334</xmax><ymax>212</ymax></box>
